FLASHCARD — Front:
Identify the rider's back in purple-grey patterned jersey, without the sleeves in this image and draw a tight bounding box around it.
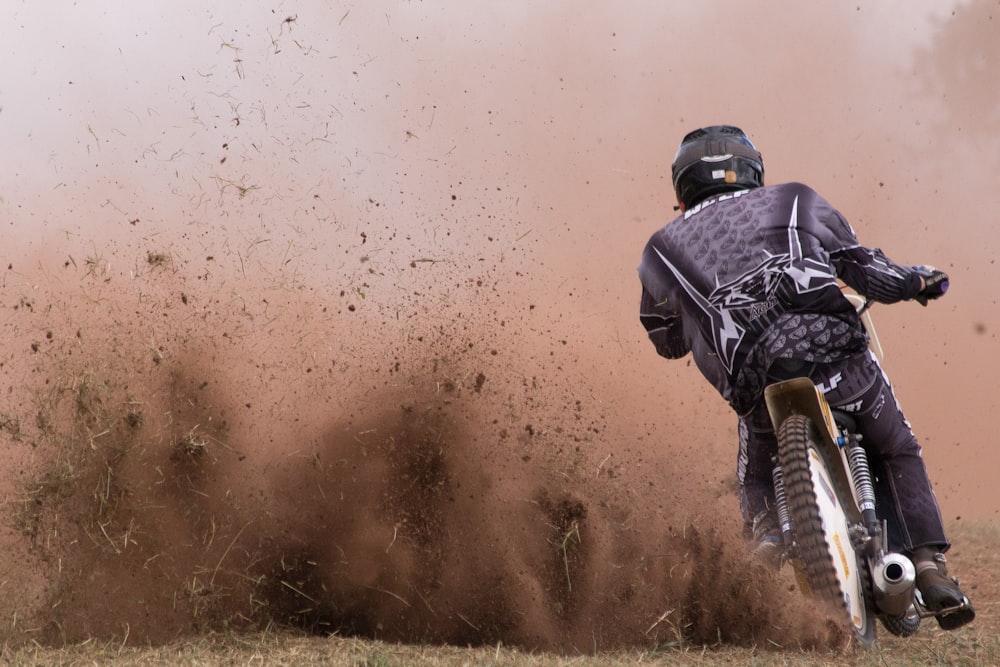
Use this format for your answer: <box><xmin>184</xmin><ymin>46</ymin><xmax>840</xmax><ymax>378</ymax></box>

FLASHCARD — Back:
<box><xmin>640</xmin><ymin>183</ymin><xmax>864</xmax><ymax>404</ymax></box>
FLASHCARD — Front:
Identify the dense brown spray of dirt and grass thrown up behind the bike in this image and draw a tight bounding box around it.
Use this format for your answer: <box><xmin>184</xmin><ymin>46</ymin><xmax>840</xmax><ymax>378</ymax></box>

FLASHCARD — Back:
<box><xmin>3</xmin><ymin>247</ymin><xmax>838</xmax><ymax>651</ymax></box>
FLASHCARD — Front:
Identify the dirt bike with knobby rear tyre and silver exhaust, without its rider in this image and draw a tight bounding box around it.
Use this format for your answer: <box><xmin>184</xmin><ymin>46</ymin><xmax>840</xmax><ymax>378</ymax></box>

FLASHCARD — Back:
<box><xmin>764</xmin><ymin>293</ymin><xmax>968</xmax><ymax>646</ymax></box>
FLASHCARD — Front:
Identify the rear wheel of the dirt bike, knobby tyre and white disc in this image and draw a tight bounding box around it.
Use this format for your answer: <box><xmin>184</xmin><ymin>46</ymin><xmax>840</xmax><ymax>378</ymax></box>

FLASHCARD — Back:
<box><xmin>777</xmin><ymin>415</ymin><xmax>875</xmax><ymax>646</ymax></box>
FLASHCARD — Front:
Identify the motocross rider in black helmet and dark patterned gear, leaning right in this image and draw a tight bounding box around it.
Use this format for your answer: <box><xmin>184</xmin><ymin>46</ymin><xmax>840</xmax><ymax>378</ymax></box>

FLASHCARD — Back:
<box><xmin>639</xmin><ymin>125</ymin><xmax>975</xmax><ymax>629</ymax></box>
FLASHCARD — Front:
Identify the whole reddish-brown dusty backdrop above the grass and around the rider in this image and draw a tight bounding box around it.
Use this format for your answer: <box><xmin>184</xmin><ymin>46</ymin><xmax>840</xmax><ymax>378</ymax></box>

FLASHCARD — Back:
<box><xmin>0</xmin><ymin>0</ymin><xmax>1000</xmax><ymax>650</ymax></box>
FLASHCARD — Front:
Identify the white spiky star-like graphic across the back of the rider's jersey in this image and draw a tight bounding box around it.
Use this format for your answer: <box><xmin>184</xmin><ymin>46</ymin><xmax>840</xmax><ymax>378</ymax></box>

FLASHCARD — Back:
<box><xmin>656</xmin><ymin>197</ymin><xmax>836</xmax><ymax>373</ymax></box>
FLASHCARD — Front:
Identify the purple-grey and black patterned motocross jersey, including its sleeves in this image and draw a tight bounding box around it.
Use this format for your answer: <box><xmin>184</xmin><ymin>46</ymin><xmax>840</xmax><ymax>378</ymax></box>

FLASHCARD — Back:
<box><xmin>639</xmin><ymin>183</ymin><xmax>920</xmax><ymax>414</ymax></box>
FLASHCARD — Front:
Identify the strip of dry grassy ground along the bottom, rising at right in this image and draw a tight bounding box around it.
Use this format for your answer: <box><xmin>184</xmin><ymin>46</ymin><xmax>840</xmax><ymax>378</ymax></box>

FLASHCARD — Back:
<box><xmin>0</xmin><ymin>522</ymin><xmax>1000</xmax><ymax>667</ymax></box>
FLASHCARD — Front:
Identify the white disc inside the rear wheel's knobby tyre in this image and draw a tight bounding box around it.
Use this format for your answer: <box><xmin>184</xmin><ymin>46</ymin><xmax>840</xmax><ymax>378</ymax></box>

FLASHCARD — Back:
<box><xmin>809</xmin><ymin>447</ymin><xmax>868</xmax><ymax>631</ymax></box>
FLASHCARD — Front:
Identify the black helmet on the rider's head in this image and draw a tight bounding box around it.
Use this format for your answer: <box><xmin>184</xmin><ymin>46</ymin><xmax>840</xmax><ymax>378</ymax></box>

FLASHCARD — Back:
<box><xmin>671</xmin><ymin>125</ymin><xmax>764</xmax><ymax>208</ymax></box>
